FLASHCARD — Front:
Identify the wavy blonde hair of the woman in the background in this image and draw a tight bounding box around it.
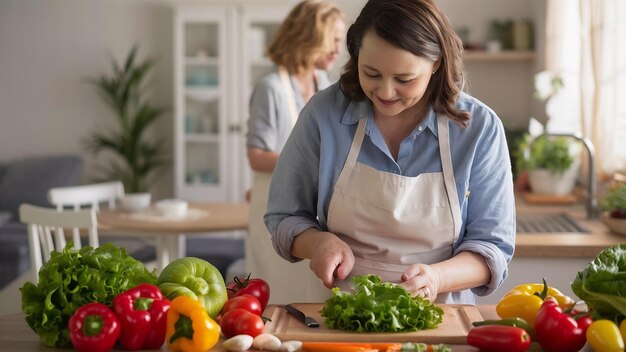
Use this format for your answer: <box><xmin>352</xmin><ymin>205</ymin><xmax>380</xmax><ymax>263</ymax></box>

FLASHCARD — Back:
<box><xmin>267</xmin><ymin>0</ymin><xmax>344</xmax><ymax>73</ymax></box>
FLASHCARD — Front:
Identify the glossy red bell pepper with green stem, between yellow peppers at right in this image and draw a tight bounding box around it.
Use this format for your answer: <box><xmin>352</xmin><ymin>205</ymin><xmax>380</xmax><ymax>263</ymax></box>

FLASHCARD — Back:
<box><xmin>535</xmin><ymin>297</ymin><xmax>591</xmax><ymax>352</ymax></box>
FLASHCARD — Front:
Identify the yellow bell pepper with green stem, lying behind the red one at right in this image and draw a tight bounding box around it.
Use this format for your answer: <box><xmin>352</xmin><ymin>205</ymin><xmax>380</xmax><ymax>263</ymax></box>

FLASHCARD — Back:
<box><xmin>496</xmin><ymin>279</ymin><xmax>576</xmax><ymax>325</ymax></box>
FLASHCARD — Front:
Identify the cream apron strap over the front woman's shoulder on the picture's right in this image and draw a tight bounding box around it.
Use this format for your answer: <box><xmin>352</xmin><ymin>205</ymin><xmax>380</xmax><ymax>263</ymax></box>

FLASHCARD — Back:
<box><xmin>437</xmin><ymin>114</ymin><xmax>461</xmax><ymax>245</ymax></box>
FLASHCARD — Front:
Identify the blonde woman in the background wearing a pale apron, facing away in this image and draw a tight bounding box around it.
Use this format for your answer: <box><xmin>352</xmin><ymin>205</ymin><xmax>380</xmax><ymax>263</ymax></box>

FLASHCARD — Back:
<box><xmin>246</xmin><ymin>0</ymin><xmax>346</xmax><ymax>303</ymax></box>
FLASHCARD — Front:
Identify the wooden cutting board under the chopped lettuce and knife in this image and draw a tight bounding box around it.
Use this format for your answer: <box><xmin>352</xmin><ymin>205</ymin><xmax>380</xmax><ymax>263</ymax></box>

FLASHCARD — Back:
<box><xmin>263</xmin><ymin>303</ymin><xmax>484</xmax><ymax>344</ymax></box>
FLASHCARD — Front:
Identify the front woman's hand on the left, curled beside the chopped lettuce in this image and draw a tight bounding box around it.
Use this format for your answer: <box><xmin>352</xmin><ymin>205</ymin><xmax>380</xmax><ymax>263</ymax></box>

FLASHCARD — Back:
<box><xmin>292</xmin><ymin>229</ymin><xmax>354</xmax><ymax>288</ymax></box>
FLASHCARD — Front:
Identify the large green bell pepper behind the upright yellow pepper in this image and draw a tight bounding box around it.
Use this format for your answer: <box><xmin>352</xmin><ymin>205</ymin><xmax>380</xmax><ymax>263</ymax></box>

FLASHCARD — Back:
<box><xmin>157</xmin><ymin>257</ymin><xmax>228</xmax><ymax>319</ymax></box>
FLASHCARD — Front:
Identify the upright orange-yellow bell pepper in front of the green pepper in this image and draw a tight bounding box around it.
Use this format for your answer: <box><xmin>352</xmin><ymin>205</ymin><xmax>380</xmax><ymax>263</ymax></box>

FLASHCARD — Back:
<box><xmin>165</xmin><ymin>296</ymin><xmax>221</xmax><ymax>352</ymax></box>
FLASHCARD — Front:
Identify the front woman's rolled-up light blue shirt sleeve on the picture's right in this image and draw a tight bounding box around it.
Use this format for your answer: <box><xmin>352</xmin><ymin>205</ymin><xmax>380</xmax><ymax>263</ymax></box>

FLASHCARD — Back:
<box><xmin>455</xmin><ymin>116</ymin><xmax>515</xmax><ymax>296</ymax></box>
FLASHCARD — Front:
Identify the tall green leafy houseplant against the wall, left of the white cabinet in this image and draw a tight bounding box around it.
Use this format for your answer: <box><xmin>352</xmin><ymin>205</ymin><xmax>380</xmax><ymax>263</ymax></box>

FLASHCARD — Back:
<box><xmin>85</xmin><ymin>46</ymin><xmax>167</xmax><ymax>193</ymax></box>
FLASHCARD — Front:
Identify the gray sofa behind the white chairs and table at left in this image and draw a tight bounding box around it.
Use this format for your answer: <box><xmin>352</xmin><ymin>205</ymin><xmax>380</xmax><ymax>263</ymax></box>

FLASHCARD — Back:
<box><xmin>0</xmin><ymin>155</ymin><xmax>244</xmax><ymax>288</ymax></box>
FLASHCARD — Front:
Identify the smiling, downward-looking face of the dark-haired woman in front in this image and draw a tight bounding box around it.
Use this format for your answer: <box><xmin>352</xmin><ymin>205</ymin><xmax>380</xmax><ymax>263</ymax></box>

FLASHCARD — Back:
<box><xmin>358</xmin><ymin>31</ymin><xmax>437</xmax><ymax>116</ymax></box>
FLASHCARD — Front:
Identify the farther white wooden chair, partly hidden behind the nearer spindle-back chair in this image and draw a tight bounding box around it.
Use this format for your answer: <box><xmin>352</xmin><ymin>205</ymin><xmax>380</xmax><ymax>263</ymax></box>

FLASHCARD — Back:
<box><xmin>48</xmin><ymin>181</ymin><xmax>124</xmax><ymax>248</ymax></box>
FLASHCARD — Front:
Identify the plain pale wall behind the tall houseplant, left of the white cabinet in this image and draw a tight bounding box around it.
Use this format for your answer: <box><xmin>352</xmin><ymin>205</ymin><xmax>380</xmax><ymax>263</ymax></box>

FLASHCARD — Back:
<box><xmin>0</xmin><ymin>0</ymin><xmax>173</xmax><ymax>198</ymax></box>
